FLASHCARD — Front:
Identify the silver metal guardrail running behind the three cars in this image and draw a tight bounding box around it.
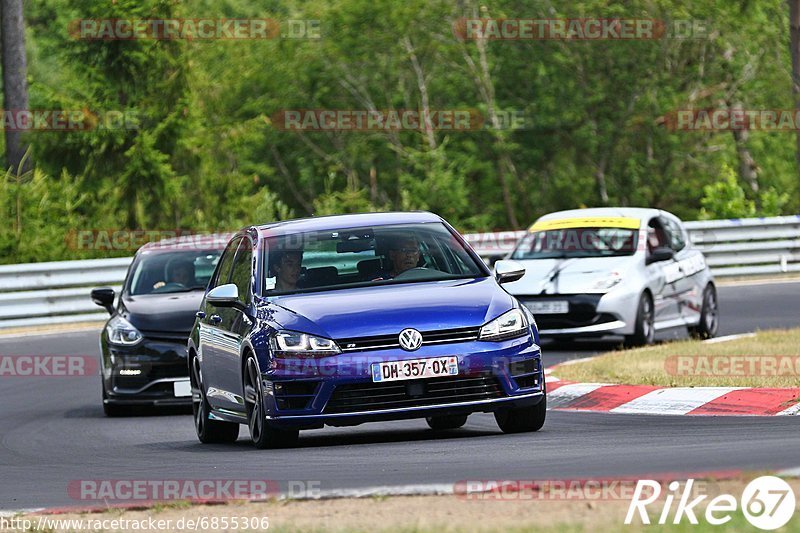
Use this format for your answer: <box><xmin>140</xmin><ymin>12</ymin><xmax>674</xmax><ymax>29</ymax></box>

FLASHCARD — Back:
<box><xmin>0</xmin><ymin>215</ymin><xmax>800</xmax><ymax>329</ymax></box>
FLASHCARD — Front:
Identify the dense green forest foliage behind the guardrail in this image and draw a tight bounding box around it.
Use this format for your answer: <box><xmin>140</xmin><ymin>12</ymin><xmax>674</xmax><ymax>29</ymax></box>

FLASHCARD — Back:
<box><xmin>0</xmin><ymin>0</ymin><xmax>800</xmax><ymax>262</ymax></box>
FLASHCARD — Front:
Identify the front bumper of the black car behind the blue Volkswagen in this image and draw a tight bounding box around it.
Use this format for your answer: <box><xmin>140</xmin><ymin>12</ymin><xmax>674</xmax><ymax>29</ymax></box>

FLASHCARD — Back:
<box><xmin>100</xmin><ymin>332</ymin><xmax>192</xmax><ymax>405</ymax></box>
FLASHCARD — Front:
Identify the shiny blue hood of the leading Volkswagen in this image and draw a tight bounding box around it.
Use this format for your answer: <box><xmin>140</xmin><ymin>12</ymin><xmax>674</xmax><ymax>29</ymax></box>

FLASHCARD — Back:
<box><xmin>267</xmin><ymin>277</ymin><xmax>514</xmax><ymax>339</ymax></box>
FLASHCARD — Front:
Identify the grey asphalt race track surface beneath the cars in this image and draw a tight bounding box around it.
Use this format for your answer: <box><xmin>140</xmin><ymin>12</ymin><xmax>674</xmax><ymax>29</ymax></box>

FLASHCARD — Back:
<box><xmin>0</xmin><ymin>283</ymin><xmax>800</xmax><ymax>510</ymax></box>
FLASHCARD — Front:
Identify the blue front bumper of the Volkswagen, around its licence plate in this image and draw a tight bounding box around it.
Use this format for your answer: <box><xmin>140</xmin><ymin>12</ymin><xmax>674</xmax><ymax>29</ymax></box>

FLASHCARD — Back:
<box><xmin>263</xmin><ymin>337</ymin><xmax>545</xmax><ymax>428</ymax></box>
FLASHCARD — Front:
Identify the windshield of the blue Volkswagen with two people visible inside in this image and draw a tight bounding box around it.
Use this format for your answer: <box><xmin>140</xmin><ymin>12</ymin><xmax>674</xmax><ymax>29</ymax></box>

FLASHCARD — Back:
<box><xmin>264</xmin><ymin>223</ymin><xmax>486</xmax><ymax>296</ymax></box>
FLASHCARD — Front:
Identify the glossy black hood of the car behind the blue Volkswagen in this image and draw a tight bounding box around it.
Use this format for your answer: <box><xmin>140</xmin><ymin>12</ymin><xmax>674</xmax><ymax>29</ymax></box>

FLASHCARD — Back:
<box><xmin>121</xmin><ymin>290</ymin><xmax>203</xmax><ymax>336</ymax></box>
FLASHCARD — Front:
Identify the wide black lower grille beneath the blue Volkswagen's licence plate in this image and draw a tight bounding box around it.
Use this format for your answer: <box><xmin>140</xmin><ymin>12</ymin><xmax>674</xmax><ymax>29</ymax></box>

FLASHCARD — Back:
<box><xmin>323</xmin><ymin>372</ymin><xmax>505</xmax><ymax>414</ymax></box>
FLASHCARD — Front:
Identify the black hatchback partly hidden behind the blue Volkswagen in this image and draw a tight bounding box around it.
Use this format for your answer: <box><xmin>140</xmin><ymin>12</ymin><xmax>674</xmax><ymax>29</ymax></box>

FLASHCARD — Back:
<box><xmin>92</xmin><ymin>235</ymin><xmax>230</xmax><ymax>416</ymax></box>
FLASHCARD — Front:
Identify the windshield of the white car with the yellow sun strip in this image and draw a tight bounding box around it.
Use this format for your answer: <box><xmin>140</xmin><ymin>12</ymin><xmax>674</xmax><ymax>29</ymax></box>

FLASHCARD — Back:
<box><xmin>511</xmin><ymin>228</ymin><xmax>639</xmax><ymax>259</ymax></box>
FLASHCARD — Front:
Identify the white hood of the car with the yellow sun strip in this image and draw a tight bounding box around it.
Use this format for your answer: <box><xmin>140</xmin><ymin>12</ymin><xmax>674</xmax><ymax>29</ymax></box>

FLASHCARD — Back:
<box><xmin>505</xmin><ymin>255</ymin><xmax>638</xmax><ymax>295</ymax></box>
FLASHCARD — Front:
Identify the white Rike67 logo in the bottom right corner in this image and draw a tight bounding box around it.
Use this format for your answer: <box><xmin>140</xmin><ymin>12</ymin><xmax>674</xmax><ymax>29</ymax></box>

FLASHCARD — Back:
<box><xmin>625</xmin><ymin>476</ymin><xmax>795</xmax><ymax>530</ymax></box>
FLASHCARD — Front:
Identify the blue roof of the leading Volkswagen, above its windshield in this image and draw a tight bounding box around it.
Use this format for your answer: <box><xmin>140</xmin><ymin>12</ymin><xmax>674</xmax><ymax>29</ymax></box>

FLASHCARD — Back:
<box><xmin>255</xmin><ymin>211</ymin><xmax>442</xmax><ymax>237</ymax></box>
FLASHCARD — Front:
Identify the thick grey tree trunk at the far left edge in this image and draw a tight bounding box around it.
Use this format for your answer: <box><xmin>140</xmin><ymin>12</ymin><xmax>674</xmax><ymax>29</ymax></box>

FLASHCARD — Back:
<box><xmin>0</xmin><ymin>0</ymin><xmax>30</xmax><ymax>173</ymax></box>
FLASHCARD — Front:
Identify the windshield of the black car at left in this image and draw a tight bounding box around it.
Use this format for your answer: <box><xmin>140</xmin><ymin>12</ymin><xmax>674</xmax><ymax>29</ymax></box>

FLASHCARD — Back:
<box><xmin>127</xmin><ymin>250</ymin><xmax>222</xmax><ymax>296</ymax></box>
